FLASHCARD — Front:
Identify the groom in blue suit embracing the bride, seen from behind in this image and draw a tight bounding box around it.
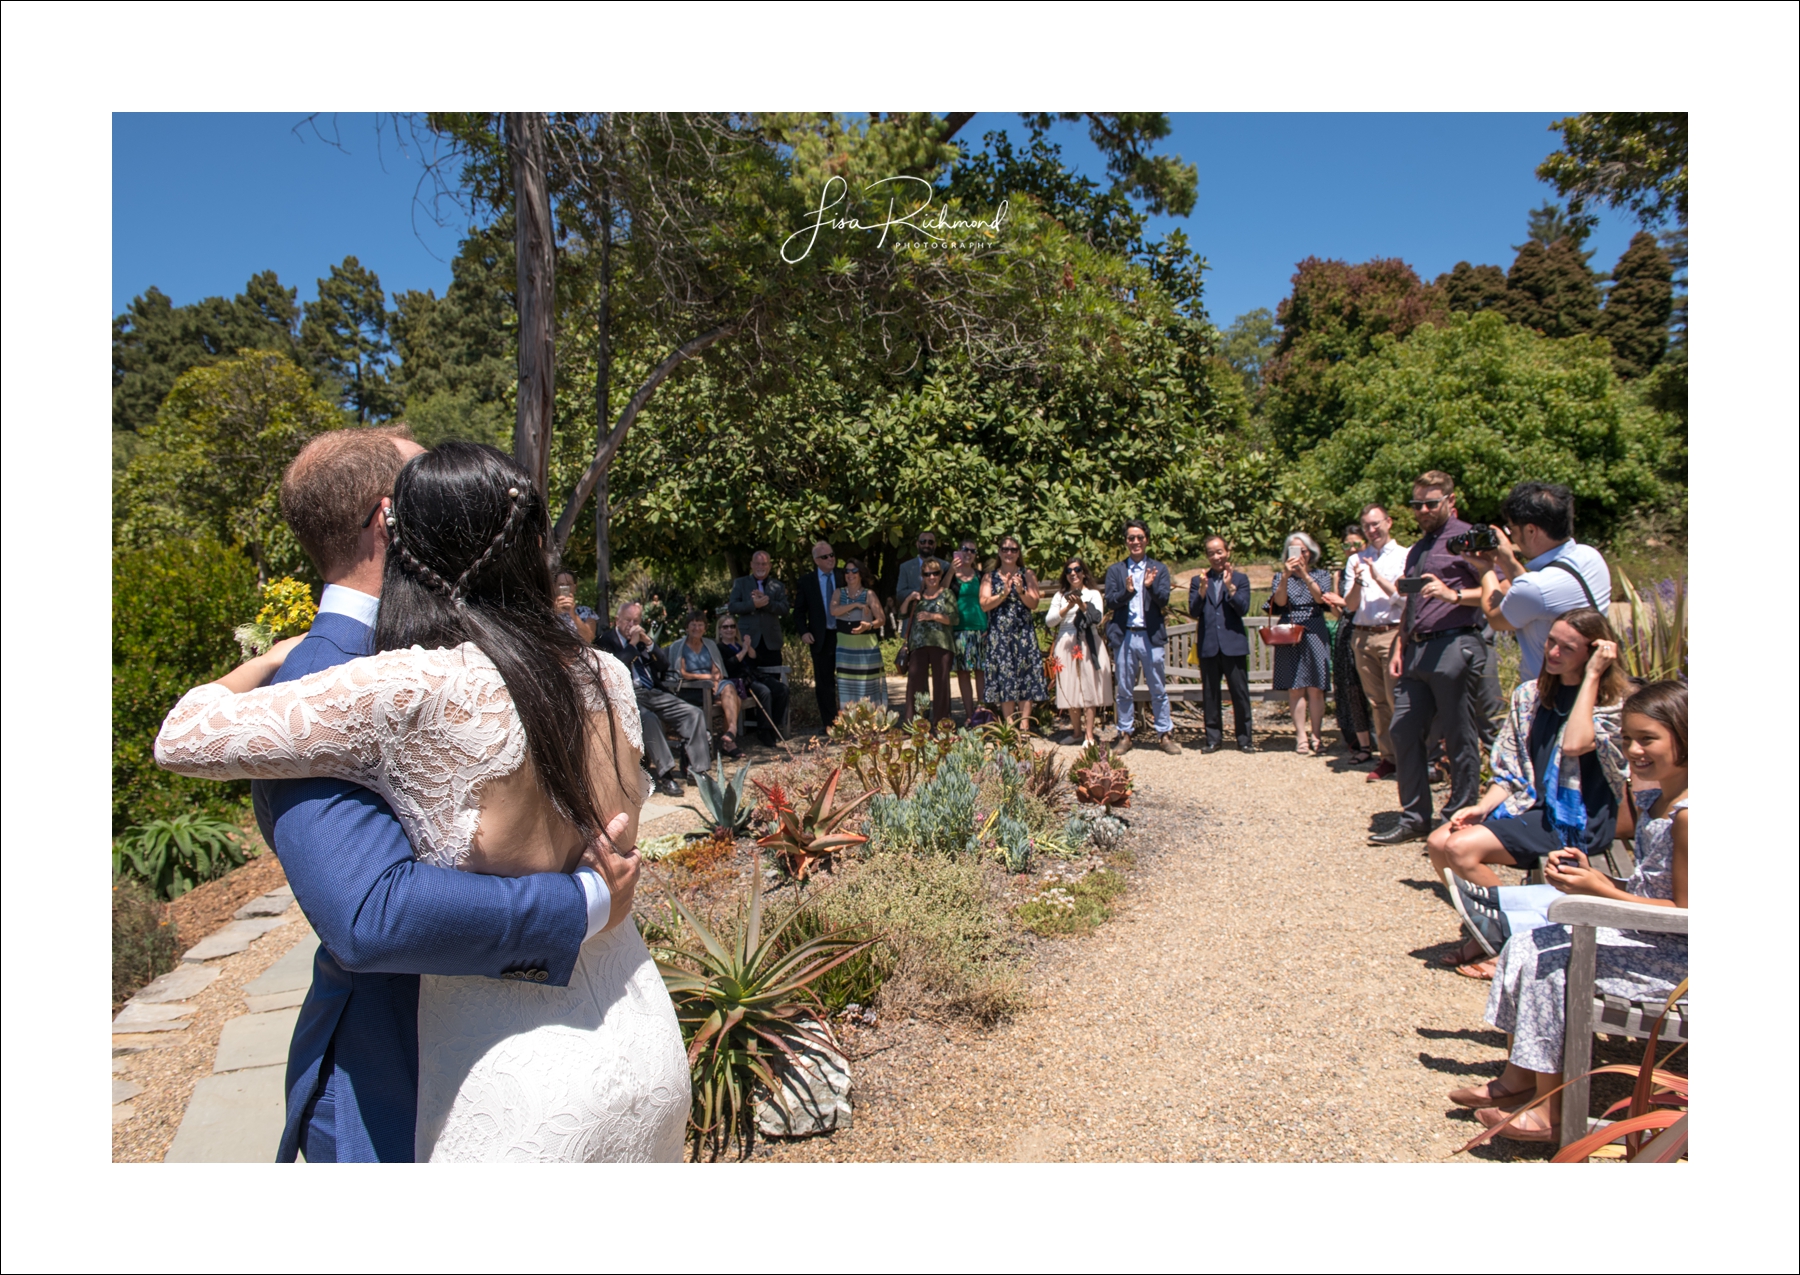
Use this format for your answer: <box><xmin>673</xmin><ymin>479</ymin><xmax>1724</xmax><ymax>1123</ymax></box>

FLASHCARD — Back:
<box><xmin>254</xmin><ymin>429</ymin><xmax>637</xmax><ymax>1163</ymax></box>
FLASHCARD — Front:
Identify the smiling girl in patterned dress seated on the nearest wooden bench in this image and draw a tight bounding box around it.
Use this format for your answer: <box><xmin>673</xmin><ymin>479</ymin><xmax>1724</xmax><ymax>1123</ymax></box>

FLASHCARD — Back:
<box><xmin>1451</xmin><ymin>680</ymin><xmax>1688</xmax><ymax>1142</ymax></box>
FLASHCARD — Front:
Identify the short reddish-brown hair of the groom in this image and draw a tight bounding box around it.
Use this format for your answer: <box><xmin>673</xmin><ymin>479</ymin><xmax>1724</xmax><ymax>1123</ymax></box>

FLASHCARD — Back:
<box><xmin>281</xmin><ymin>425</ymin><xmax>410</xmax><ymax>578</ymax></box>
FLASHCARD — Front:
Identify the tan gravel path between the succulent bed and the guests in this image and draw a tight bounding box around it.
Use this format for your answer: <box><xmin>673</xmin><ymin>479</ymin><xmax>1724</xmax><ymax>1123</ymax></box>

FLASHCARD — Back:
<box><xmin>767</xmin><ymin>722</ymin><xmax>1541</xmax><ymax>1162</ymax></box>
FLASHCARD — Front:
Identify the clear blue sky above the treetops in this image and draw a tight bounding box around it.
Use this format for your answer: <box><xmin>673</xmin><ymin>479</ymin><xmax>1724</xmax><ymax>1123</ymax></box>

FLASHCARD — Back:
<box><xmin>112</xmin><ymin>112</ymin><xmax>1636</xmax><ymax>328</ymax></box>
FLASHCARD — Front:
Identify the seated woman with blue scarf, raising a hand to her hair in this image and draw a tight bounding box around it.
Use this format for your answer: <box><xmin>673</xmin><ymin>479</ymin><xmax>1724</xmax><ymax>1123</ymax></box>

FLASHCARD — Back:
<box><xmin>1426</xmin><ymin>607</ymin><xmax>1627</xmax><ymax>978</ymax></box>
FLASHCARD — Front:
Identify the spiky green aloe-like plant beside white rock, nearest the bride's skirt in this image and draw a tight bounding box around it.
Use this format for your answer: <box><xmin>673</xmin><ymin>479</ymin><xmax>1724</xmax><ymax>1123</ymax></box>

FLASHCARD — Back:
<box><xmin>657</xmin><ymin>863</ymin><xmax>875</xmax><ymax>1160</ymax></box>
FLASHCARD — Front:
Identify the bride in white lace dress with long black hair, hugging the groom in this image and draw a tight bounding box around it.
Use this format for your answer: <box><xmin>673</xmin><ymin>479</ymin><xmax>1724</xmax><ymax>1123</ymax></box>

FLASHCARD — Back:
<box><xmin>157</xmin><ymin>443</ymin><xmax>689</xmax><ymax>1162</ymax></box>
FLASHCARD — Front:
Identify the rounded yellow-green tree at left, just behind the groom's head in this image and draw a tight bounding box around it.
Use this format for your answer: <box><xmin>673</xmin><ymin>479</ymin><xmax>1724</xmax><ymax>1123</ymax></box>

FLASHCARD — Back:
<box><xmin>113</xmin><ymin>349</ymin><xmax>346</xmax><ymax>582</ymax></box>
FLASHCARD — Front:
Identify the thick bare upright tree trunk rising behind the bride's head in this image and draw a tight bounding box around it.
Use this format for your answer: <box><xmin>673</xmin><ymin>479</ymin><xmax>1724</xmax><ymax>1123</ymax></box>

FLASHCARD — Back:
<box><xmin>506</xmin><ymin>112</ymin><xmax>560</xmax><ymax>493</ymax></box>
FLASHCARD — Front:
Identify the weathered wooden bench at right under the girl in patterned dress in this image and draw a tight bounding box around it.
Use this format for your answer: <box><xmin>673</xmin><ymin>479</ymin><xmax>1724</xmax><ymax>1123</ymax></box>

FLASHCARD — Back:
<box><xmin>1548</xmin><ymin>895</ymin><xmax>1688</xmax><ymax>1147</ymax></box>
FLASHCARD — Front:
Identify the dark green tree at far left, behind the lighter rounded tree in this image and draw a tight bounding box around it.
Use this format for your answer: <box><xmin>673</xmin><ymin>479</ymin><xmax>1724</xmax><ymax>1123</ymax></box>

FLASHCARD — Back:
<box><xmin>113</xmin><ymin>270</ymin><xmax>301</xmax><ymax>443</ymax></box>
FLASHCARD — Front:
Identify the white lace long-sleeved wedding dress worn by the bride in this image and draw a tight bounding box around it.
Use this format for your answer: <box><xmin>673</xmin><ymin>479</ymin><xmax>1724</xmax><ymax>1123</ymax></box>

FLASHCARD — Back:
<box><xmin>157</xmin><ymin>643</ymin><xmax>689</xmax><ymax>1162</ymax></box>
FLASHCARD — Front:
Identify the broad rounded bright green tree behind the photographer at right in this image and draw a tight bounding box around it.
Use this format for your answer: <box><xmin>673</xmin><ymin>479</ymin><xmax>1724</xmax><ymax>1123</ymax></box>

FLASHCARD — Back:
<box><xmin>1289</xmin><ymin>312</ymin><xmax>1679</xmax><ymax>540</ymax></box>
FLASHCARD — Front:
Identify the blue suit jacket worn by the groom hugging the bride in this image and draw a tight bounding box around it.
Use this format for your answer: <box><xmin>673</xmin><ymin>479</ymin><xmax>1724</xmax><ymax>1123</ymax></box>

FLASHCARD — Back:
<box><xmin>252</xmin><ymin>614</ymin><xmax>587</xmax><ymax>1162</ymax></box>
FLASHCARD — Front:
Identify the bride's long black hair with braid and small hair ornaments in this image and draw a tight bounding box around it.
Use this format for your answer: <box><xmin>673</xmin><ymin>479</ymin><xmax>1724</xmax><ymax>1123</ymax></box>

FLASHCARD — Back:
<box><xmin>374</xmin><ymin>443</ymin><xmax>625</xmax><ymax>836</ymax></box>
